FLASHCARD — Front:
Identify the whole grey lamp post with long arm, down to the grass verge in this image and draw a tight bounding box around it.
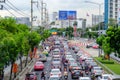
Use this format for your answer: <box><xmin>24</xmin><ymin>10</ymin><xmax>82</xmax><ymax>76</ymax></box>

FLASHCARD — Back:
<box><xmin>85</xmin><ymin>1</ymin><xmax>103</xmax><ymax>56</ymax></box>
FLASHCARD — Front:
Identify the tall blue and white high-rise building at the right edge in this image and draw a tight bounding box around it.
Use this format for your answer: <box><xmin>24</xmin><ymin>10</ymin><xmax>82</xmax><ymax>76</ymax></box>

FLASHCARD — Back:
<box><xmin>104</xmin><ymin>0</ymin><xmax>120</xmax><ymax>30</ymax></box>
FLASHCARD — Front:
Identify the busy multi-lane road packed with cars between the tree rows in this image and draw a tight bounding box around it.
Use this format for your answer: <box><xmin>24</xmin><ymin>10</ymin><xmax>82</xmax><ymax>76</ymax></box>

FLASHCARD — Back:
<box><xmin>25</xmin><ymin>36</ymin><xmax>113</xmax><ymax>80</ymax></box>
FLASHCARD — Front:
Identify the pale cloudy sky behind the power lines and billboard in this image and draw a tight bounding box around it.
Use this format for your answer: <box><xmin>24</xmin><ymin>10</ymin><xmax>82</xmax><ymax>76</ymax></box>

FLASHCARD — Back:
<box><xmin>0</xmin><ymin>0</ymin><xmax>104</xmax><ymax>25</ymax></box>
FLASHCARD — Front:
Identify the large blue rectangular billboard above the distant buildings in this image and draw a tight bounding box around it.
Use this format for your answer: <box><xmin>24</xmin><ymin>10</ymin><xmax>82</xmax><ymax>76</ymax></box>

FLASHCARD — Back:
<box><xmin>59</xmin><ymin>11</ymin><xmax>77</xmax><ymax>20</ymax></box>
